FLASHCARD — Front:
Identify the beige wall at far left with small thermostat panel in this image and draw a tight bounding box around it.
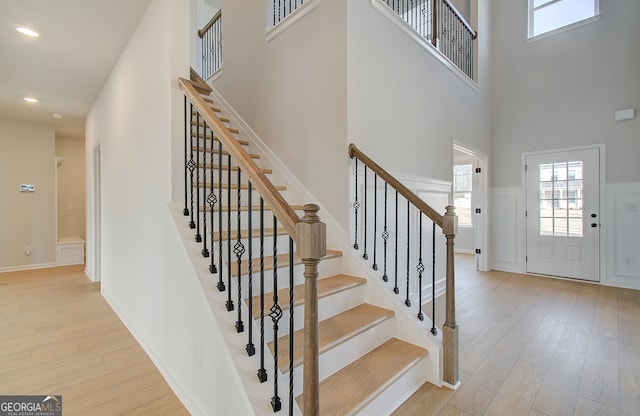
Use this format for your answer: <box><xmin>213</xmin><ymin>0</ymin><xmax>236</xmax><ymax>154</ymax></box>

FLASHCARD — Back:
<box><xmin>0</xmin><ymin>119</ymin><xmax>56</xmax><ymax>271</ymax></box>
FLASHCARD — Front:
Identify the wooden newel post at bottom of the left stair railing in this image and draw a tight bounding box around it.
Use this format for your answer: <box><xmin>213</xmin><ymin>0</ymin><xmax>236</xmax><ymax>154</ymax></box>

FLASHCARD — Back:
<box><xmin>296</xmin><ymin>204</ymin><xmax>327</xmax><ymax>416</ymax></box>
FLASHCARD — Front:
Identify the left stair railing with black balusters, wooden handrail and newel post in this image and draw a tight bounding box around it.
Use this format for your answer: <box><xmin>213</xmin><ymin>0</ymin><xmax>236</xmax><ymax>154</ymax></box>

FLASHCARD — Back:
<box><xmin>180</xmin><ymin>71</ymin><xmax>326</xmax><ymax>415</ymax></box>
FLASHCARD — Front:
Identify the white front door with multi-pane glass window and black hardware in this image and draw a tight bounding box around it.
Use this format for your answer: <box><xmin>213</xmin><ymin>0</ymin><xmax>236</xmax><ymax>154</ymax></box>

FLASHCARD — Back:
<box><xmin>525</xmin><ymin>148</ymin><xmax>600</xmax><ymax>281</ymax></box>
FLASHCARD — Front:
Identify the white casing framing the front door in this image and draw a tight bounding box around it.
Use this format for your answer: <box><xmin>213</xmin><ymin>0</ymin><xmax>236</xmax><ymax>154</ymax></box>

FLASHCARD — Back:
<box><xmin>520</xmin><ymin>143</ymin><xmax>607</xmax><ymax>284</ymax></box>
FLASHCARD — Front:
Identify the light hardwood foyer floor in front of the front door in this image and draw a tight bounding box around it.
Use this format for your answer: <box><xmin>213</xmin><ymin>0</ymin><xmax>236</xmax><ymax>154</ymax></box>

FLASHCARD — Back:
<box><xmin>394</xmin><ymin>255</ymin><xmax>640</xmax><ymax>416</ymax></box>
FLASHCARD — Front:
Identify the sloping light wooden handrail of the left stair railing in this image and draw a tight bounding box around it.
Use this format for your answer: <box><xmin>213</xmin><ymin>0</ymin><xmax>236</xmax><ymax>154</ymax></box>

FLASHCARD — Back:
<box><xmin>179</xmin><ymin>78</ymin><xmax>300</xmax><ymax>236</ymax></box>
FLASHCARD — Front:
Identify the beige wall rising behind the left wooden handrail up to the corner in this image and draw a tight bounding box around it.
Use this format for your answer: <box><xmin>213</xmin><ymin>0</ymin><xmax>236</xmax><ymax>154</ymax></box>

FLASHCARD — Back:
<box><xmin>214</xmin><ymin>0</ymin><xmax>348</xmax><ymax>228</ymax></box>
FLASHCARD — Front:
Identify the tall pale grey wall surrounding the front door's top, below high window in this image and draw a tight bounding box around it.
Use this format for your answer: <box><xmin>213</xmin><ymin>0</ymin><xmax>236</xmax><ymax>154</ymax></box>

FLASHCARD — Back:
<box><xmin>493</xmin><ymin>0</ymin><xmax>640</xmax><ymax>187</ymax></box>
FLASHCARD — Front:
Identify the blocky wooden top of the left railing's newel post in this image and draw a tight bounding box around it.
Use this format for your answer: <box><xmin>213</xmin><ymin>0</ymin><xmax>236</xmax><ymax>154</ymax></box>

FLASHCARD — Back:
<box><xmin>296</xmin><ymin>204</ymin><xmax>327</xmax><ymax>259</ymax></box>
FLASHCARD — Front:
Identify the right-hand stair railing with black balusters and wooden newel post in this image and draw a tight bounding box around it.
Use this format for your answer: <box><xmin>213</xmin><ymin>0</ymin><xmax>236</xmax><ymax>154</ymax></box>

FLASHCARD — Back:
<box><xmin>349</xmin><ymin>144</ymin><xmax>459</xmax><ymax>385</ymax></box>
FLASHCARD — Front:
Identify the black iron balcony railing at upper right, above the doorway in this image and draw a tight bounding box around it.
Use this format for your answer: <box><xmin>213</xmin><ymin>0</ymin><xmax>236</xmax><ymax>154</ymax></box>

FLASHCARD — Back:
<box><xmin>380</xmin><ymin>0</ymin><xmax>478</xmax><ymax>79</ymax></box>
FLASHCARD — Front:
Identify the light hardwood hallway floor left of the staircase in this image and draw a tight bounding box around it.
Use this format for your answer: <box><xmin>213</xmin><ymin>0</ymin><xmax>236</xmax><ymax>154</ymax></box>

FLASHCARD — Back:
<box><xmin>0</xmin><ymin>266</ymin><xmax>189</xmax><ymax>416</ymax></box>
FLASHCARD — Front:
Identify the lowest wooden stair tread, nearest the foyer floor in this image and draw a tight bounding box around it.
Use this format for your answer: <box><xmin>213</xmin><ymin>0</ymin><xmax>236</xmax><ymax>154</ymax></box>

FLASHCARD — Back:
<box><xmin>296</xmin><ymin>338</ymin><xmax>427</xmax><ymax>416</ymax></box>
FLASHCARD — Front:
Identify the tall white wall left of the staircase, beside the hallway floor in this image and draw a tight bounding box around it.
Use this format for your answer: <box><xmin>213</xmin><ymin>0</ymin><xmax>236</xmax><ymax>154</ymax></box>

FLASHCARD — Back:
<box><xmin>86</xmin><ymin>0</ymin><xmax>249</xmax><ymax>415</ymax></box>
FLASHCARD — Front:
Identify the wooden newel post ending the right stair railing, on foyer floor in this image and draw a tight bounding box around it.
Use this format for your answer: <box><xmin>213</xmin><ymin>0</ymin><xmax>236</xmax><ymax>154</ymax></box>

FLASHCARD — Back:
<box><xmin>442</xmin><ymin>206</ymin><xmax>459</xmax><ymax>386</ymax></box>
